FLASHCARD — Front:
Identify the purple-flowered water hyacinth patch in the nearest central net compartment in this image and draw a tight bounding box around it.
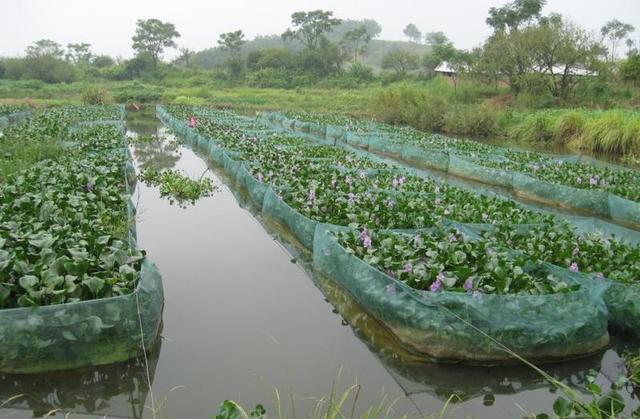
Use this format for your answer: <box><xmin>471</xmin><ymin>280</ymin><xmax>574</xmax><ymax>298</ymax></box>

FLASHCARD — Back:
<box><xmin>336</xmin><ymin>227</ymin><xmax>579</xmax><ymax>298</ymax></box>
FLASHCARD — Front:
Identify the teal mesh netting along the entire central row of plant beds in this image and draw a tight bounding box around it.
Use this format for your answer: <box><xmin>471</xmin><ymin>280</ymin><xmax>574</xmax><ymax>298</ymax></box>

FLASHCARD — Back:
<box><xmin>158</xmin><ymin>107</ymin><xmax>624</xmax><ymax>363</ymax></box>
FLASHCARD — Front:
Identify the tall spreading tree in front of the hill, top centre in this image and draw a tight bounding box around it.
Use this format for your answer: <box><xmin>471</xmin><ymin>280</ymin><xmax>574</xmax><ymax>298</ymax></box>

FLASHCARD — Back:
<box><xmin>282</xmin><ymin>10</ymin><xmax>341</xmax><ymax>50</ymax></box>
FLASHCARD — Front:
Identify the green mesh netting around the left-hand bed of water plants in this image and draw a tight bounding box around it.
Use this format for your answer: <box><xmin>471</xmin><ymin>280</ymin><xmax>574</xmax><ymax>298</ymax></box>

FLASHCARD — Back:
<box><xmin>0</xmin><ymin>117</ymin><xmax>164</xmax><ymax>374</ymax></box>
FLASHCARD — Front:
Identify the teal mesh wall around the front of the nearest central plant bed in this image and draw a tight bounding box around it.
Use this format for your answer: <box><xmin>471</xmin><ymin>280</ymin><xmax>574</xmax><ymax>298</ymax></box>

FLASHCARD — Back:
<box><xmin>313</xmin><ymin>225</ymin><xmax>609</xmax><ymax>364</ymax></box>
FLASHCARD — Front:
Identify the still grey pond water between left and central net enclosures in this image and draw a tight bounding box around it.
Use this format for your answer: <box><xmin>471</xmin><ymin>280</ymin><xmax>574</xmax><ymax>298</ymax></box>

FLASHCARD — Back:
<box><xmin>0</xmin><ymin>110</ymin><xmax>638</xmax><ymax>418</ymax></box>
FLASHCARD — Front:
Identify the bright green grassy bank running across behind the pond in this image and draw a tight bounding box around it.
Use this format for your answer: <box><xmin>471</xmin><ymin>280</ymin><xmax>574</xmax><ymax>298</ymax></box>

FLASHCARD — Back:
<box><xmin>5</xmin><ymin>73</ymin><xmax>640</xmax><ymax>155</ymax></box>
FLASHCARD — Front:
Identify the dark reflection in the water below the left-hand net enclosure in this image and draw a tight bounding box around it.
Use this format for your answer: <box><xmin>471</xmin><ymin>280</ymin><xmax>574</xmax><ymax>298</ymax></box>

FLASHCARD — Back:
<box><xmin>0</xmin><ymin>339</ymin><xmax>161</xmax><ymax>418</ymax></box>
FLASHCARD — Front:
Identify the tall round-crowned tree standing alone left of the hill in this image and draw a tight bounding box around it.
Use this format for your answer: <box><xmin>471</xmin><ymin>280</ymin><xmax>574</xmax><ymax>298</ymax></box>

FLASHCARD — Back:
<box><xmin>131</xmin><ymin>19</ymin><xmax>180</xmax><ymax>68</ymax></box>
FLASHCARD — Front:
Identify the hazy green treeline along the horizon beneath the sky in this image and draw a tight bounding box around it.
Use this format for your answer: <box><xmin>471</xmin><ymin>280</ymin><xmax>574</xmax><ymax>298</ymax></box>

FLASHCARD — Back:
<box><xmin>0</xmin><ymin>0</ymin><xmax>640</xmax><ymax>106</ymax></box>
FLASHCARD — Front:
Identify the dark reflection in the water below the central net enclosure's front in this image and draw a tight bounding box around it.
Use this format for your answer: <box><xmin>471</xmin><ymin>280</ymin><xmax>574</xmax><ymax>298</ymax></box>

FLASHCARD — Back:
<box><xmin>315</xmin><ymin>275</ymin><xmax>637</xmax><ymax>407</ymax></box>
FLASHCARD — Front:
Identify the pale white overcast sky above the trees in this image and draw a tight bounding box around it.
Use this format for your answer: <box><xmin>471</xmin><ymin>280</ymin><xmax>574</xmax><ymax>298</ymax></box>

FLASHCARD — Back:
<box><xmin>0</xmin><ymin>0</ymin><xmax>640</xmax><ymax>58</ymax></box>
